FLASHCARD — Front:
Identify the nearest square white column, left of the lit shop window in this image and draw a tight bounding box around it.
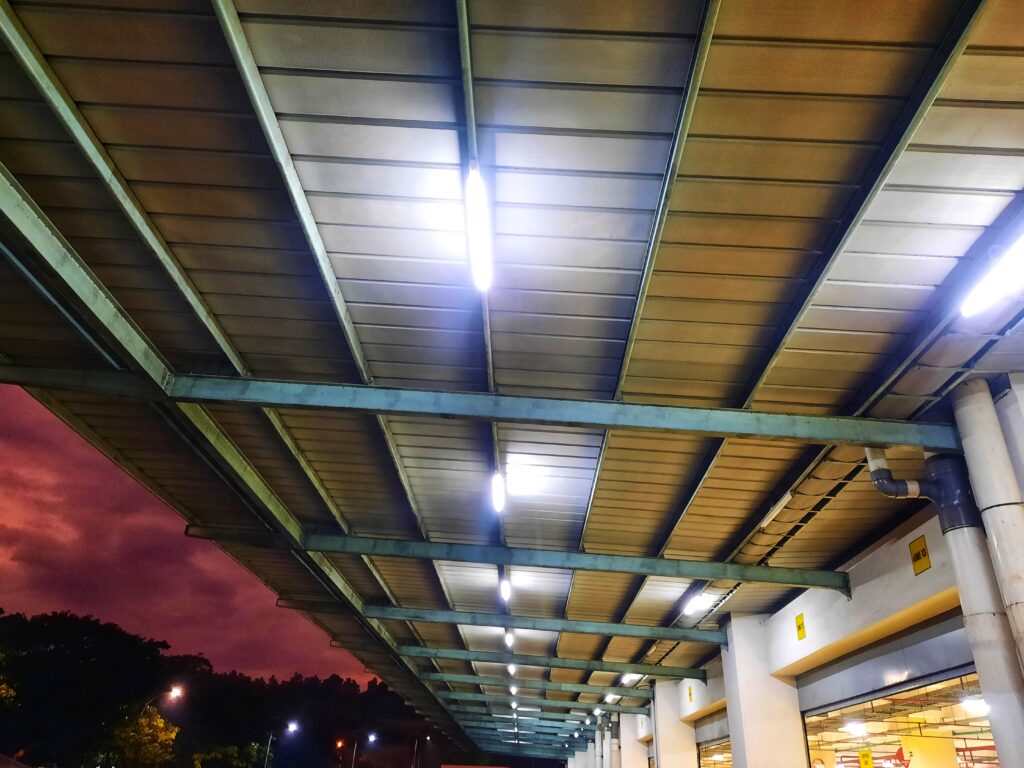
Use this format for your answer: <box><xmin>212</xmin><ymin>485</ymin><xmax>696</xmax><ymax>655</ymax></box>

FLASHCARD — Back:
<box><xmin>722</xmin><ymin>613</ymin><xmax>808</xmax><ymax>768</ymax></box>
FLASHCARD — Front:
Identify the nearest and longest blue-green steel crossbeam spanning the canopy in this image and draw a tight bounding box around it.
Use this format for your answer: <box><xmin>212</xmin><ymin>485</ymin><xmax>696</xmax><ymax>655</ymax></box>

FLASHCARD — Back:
<box><xmin>0</xmin><ymin>366</ymin><xmax>961</xmax><ymax>452</ymax></box>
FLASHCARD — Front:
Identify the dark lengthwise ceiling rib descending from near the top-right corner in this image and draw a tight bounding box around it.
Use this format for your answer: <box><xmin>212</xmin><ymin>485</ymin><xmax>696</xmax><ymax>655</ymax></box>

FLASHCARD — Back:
<box><xmin>610</xmin><ymin>0</ymin><xmax>985</xmax><ymax>657</ymax></box>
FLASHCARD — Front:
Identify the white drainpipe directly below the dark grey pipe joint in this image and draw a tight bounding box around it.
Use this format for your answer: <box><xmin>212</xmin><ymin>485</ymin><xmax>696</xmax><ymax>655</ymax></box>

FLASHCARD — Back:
<box><xmin>945</xmin><ymin>527</ymin><xmax>1024</xmax><ymax>766</ymax></box>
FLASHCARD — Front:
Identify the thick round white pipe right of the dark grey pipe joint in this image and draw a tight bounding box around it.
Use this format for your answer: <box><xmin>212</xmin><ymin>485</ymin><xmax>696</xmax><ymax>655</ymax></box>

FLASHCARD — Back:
<box><xmin>953</xmin><ymin>379</ymin><xmax>1024</xmax><ymax>658</ymax></box>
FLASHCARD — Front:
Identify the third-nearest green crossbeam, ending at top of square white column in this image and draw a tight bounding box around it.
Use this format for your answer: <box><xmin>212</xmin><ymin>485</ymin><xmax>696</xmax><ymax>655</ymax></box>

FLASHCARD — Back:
<box><xmin>346</xmin><ymin>600</ymin><xmax>726</xmax><ymax>645</ymax></box>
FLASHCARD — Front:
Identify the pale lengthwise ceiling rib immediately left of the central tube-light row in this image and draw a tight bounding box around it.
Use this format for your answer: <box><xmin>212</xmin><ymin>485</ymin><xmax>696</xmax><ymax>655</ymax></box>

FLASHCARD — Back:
<box><xmin>212</xmin><ymin>0</ymin><xmax>477</xmax><ymax>720</ymax></box>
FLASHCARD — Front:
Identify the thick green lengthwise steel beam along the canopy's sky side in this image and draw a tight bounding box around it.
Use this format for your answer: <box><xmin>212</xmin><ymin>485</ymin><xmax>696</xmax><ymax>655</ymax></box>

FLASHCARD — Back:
<box><xmin>0</xmin><ymin>165</ymin><xmax>464</xmax><ymax>745</ymax></box>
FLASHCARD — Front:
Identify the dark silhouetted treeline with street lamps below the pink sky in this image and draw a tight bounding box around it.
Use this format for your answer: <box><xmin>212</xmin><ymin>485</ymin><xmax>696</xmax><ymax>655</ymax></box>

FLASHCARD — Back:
<box><xmin>0</xmin><ymin>610</ymin><xmax>536</xmax><ymax>768</ymax></box>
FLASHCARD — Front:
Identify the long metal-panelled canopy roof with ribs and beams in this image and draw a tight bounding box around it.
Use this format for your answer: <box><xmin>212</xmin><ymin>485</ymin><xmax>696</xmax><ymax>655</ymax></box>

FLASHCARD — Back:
<box><xmin>0</xmin><ymin>0</ymin><xmax>1024</xmax><ymax>756</ymax></box>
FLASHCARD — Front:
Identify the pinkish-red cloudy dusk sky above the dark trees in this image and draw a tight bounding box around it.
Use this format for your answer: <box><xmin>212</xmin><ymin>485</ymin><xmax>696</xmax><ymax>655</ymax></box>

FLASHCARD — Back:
<box><xmin>0</xmin><ymin>385</ymin><xmax>372</xmax><ymax>682</ymax></box>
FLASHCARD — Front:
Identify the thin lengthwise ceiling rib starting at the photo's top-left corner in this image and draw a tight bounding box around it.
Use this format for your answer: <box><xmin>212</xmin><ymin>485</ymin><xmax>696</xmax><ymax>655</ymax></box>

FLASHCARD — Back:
<box><xmin>0</xmin><ymin>0</ymin><xmax>419</xmax><ymax>655</ymax></box>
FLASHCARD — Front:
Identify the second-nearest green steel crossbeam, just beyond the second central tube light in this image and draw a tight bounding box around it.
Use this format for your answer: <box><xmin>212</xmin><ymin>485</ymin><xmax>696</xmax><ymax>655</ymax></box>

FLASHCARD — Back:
<box><xmin>185</xmin><ymin>525</ymin><xmax>850</xmax><ymax>595</ymax></box>
